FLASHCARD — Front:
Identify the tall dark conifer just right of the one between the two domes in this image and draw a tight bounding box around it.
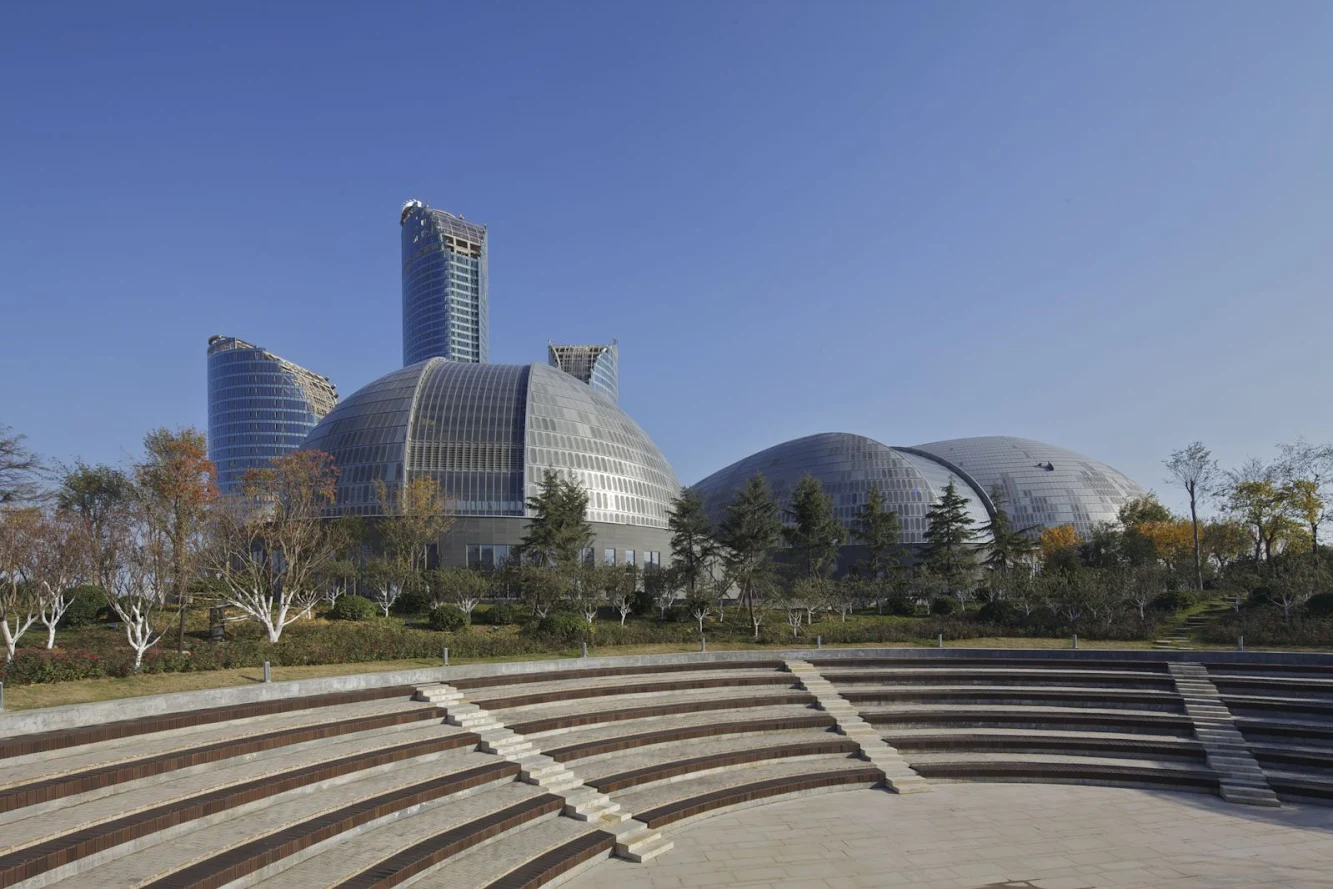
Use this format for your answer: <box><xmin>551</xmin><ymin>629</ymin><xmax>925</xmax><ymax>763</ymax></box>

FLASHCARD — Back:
<box><xmin>717</xmin><ymin>473</ymin><xmax>782</xmax><ymax>638</ymax></box>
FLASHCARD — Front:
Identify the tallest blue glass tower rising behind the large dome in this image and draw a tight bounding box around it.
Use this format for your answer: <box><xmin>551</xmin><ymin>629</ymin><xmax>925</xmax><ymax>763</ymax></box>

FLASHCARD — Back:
<box><xmin>399</xmin><ymin>201</ymin><xmax>491</xmax><ymax>367</ymax></box>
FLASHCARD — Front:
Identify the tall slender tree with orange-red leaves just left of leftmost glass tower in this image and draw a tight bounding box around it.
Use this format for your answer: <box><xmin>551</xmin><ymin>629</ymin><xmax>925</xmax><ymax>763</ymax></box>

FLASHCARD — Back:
<box><xmin>135</xmin><ymin>428</ymin><xmax>217</xmax><ymax>652</ymax></box>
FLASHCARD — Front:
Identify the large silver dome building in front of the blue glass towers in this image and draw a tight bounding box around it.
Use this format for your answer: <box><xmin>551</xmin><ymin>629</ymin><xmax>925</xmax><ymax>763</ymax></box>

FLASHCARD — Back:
<box><xmin>303</xmin><ymin>359</ymin><xmax>680</xmax><ymax>568</ymax></box>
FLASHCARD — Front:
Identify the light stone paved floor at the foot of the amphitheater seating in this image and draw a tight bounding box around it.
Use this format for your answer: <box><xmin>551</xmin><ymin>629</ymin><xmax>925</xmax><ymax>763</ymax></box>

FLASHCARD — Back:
<box><xmin>564</xmin><ymin>784</ymin><xmax>1333</xmax><ymax>889</ymax></box>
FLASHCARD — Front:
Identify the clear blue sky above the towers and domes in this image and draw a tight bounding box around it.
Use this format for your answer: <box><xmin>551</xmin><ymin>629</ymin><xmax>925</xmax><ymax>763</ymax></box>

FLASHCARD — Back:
<box><xmin>0</xmin><ymin>0</ymin><xmax>1333</xmax><ymax>511</ymax></box>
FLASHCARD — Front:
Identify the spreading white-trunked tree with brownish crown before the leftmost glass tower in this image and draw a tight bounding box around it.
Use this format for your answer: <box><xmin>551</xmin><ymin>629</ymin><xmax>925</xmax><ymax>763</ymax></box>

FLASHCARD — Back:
<box><xmin>208</xmin><ymin>450</ymin><xmax>339</xmax><ymax>642</ymax></box>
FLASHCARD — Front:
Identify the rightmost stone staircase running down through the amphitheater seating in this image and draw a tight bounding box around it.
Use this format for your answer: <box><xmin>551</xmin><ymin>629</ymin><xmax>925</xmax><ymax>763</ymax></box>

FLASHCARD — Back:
<box><xmin>1168</xmin><ymin>661</ymin><xmax>1281</xmax><ymax>806</ymax></box>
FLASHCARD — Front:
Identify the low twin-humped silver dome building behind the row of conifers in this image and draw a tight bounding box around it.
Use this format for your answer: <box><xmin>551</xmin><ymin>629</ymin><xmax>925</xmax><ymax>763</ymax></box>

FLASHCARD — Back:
<box><xmin>693</xmin><ymin>432</ymin><xmax>1148</xmax><ymax>557</ymax></box>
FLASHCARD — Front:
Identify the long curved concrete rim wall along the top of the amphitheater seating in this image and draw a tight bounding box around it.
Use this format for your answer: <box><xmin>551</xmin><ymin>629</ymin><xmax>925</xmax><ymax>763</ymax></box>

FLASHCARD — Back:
<box><xmin>0</xmin><ymin>648</ymin><xmax>1333</xmax><ymax>737</ymax></box>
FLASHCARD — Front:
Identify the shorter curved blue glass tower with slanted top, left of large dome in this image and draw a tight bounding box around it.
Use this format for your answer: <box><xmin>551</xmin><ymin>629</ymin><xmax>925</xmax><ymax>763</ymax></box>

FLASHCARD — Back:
<box><xmin>208</xmin><ymin>336</ymin><xmax>337</xmax><ymax>493</ymax></box>
